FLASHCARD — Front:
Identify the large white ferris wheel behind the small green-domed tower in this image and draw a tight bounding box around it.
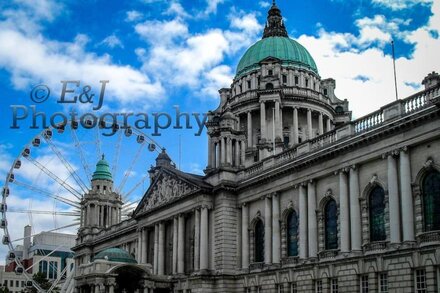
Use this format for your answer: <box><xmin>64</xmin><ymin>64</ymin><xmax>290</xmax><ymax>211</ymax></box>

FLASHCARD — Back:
<box><xmin>0</xmin><ymin>120</ymin><xmax>162</xmax><ymax>292</ymax></box>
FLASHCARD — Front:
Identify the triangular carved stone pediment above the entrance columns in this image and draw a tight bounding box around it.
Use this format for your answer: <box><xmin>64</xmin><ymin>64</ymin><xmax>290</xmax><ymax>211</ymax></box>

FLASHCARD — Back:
<box><xmin>134</xmin><ymin>171</ymin><xmax>200</xmax><ymax>215</ymax></box>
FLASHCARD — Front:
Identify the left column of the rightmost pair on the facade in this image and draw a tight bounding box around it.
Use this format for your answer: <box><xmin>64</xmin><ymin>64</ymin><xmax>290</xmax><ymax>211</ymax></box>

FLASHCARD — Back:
<box><xmin>387</xmin><ymin>154</ymin><xmax>400</xmax><ymax>243</ymax></box>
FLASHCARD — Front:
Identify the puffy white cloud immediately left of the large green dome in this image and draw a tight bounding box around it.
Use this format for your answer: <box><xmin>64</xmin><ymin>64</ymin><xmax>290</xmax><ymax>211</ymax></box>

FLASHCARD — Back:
<box><xmin>135</xmin><ymin>11</ymin><xmax>262</xmax><ymax>97</ymax></box>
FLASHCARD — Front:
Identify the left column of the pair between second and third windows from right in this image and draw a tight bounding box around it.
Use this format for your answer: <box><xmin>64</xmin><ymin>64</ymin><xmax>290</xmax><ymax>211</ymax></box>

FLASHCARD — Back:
<box><xmin>339</xmin><ymin>170</ymin><xmax>350</xmax><ymax>252</ymax></box>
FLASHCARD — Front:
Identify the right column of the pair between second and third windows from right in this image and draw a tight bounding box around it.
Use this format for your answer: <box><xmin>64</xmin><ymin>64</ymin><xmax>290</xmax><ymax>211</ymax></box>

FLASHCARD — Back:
<box><xmin>350</xmin><ymin>166</ymin><xmax>362</xmax><ymax>251</ymax></box>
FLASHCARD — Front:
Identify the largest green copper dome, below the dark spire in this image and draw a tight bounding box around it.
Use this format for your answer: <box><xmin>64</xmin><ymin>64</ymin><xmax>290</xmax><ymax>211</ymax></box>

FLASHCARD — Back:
<box><xmin>237</xmin><ymin>36</ymin><xmax>318</xmax><ymax>77</ymax></box>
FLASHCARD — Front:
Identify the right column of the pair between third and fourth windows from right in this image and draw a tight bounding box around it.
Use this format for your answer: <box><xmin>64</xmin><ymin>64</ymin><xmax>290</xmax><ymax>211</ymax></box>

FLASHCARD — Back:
<box><xmin>307</xmin><ymin>180</ymin><xmax>318</xmax><ymax>257</ymax></box>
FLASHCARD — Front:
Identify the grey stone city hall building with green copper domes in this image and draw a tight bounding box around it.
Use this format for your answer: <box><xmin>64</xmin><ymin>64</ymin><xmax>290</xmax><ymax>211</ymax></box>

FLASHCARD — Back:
<box><xmin>73</xmin><ymin>4</ymin><xmax>440</xmax><ymax>293</ymax></box>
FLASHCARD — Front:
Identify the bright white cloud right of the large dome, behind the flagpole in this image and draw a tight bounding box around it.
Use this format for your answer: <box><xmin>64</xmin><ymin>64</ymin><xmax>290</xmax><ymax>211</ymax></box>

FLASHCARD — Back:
<box><xmin>298</xmin><ymin>2</ymin><xmax>440</xmax><ymax>117</ymax></box>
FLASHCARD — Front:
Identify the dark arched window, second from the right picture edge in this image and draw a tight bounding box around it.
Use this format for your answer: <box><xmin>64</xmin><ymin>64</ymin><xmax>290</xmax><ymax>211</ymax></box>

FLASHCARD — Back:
<box><xmin>369</xmin><ymin>186</ymin><xmax>387</xmax><ymax>241</ymax></box>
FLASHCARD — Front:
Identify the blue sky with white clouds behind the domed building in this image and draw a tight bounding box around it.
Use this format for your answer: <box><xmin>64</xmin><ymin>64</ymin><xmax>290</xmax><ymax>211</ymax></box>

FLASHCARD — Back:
<box><xmin>0</xmin><ymin>0</ymin><xmax>440</xmax><ymax>260</ymax></box>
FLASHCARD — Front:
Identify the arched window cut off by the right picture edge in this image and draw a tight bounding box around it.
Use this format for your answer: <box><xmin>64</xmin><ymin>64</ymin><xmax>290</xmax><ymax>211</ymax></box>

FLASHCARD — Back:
<box><xmin>422</xmin><ymin>170</ymin><xmax>440</xmax><ymax>232</ymax></box>
